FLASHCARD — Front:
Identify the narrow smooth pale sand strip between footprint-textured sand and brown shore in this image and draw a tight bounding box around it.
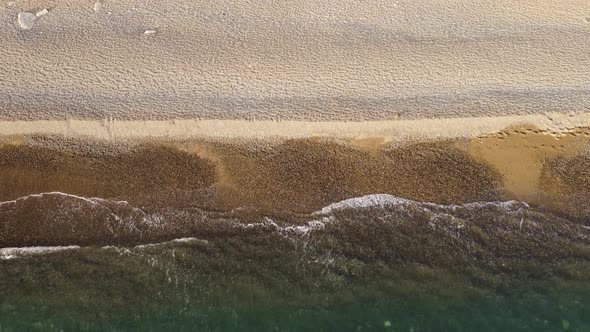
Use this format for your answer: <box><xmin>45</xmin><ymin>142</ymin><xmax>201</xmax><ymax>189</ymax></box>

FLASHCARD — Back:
<box><xmin>0</xmin><ymin>113</ymin><xmax>590</xmax><ymax>141</ymax></box>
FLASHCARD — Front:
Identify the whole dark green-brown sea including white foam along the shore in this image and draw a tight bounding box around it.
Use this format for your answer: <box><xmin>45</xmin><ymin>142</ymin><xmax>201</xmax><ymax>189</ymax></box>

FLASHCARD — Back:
<box><xmin>0</xmin><ymin>193</ymin><xmax>590</xmax><ymax>331</ymax></box>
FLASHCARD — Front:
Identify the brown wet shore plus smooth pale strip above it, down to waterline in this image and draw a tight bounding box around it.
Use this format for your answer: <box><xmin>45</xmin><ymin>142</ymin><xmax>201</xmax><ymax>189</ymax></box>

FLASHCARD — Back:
<box><xmin>0</xmin><ymin>114</ymin><xmax>590</xmax><ymax>223</ymax></box>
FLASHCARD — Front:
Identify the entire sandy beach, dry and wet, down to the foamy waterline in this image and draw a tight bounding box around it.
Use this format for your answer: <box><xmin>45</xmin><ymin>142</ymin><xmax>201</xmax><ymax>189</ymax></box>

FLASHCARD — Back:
<box><xmin>0</xmin><ymin>0</ymin><xmax>590</xmax><ymax>220</ymax></box>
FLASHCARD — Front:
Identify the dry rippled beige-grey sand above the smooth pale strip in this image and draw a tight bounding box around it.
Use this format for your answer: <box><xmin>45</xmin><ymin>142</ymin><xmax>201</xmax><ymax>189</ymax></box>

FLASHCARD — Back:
<box><xmin>0</xmin><ymin>0</ymin><xmax>590</xmax><ymax>121</ymax></box>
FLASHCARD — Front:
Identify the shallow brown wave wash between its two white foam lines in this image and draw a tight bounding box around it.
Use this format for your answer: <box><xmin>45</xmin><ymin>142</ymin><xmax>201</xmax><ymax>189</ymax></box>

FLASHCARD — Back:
<box><xmin>0</xmin><ymin>192</ymin><xmax>587</xmax><ymax>248</ymax></box>
